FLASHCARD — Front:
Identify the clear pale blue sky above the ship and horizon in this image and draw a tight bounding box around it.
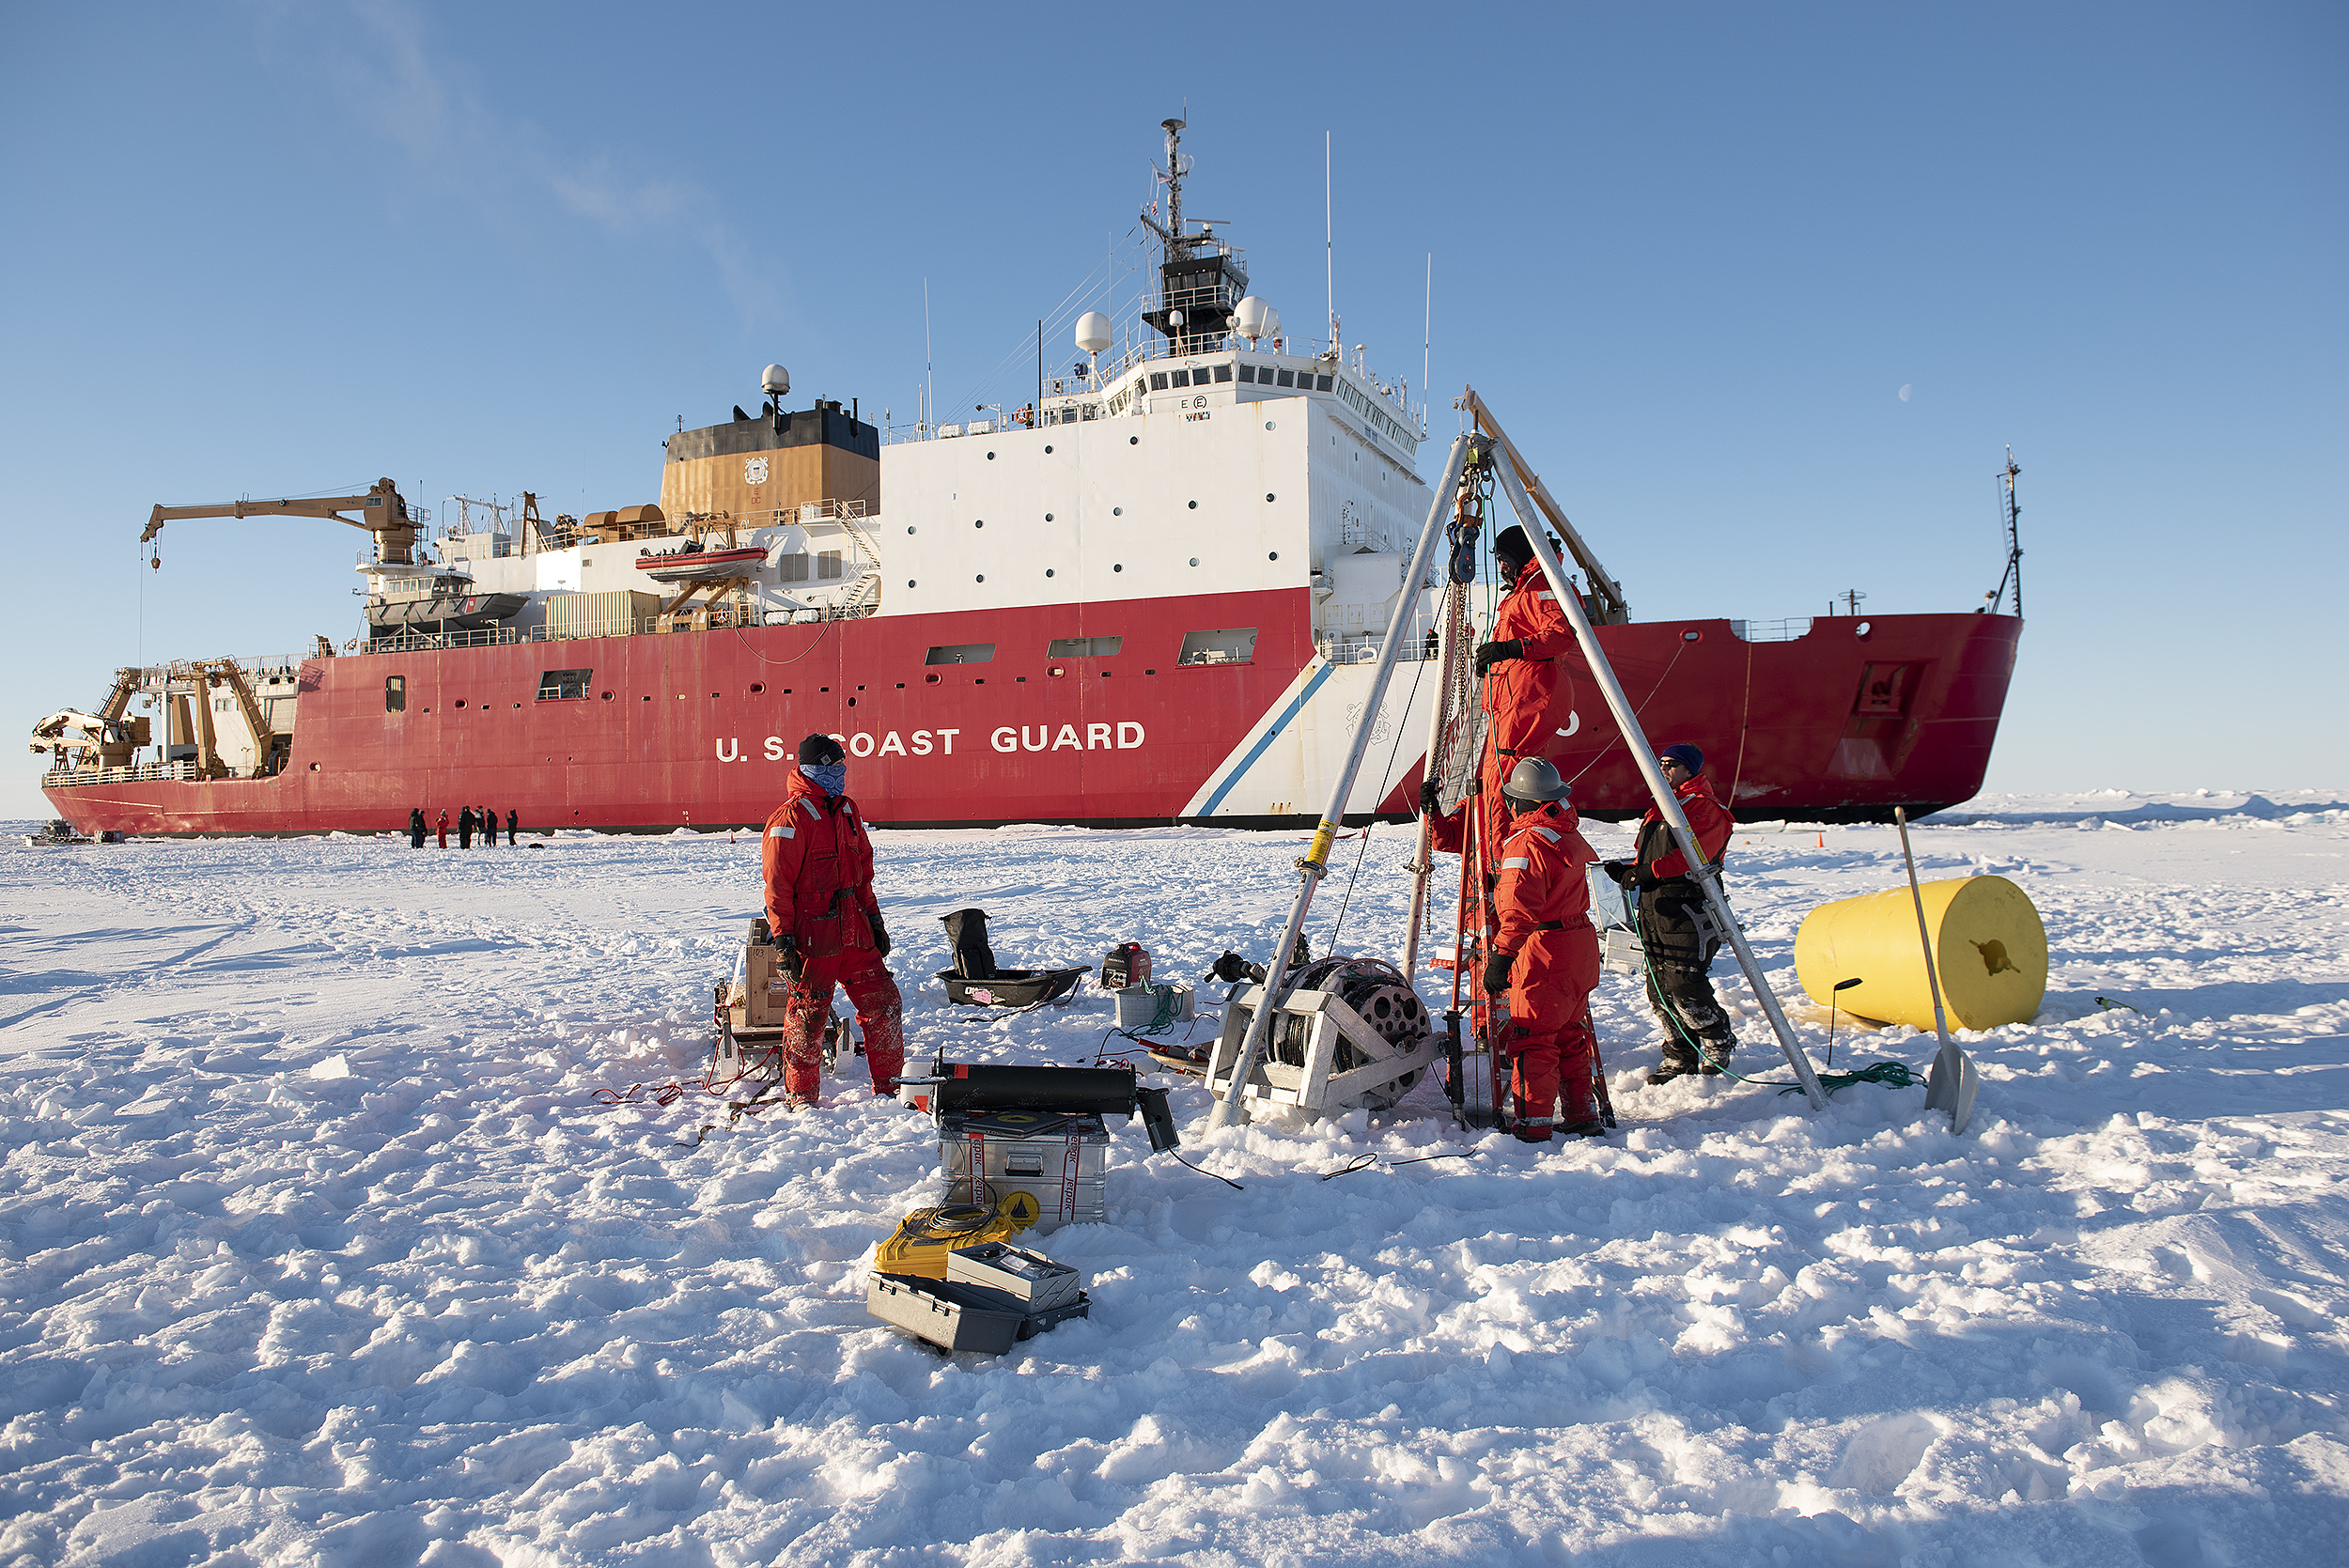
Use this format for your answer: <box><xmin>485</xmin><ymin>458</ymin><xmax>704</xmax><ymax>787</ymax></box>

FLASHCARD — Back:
<box><xmin>0</xmin><ymin>5</ymin><xmax>2349</xmax><ymax>816</ymax></box>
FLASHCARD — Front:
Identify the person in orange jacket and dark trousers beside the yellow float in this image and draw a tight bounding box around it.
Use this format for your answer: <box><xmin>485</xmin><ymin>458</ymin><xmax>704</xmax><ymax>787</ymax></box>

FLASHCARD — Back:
<box><xmin>1602</xmin><ymin>744</ymin><xmax>1738</xmax><ymax>1084</ymax></box>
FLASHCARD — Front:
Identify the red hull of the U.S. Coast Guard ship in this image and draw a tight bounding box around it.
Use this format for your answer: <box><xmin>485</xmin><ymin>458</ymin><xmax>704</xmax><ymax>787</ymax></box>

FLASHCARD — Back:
<box><xmin>45</xmin><ymin>589</ymin><xmax>2023</xmax><ymax>835</ymax></box>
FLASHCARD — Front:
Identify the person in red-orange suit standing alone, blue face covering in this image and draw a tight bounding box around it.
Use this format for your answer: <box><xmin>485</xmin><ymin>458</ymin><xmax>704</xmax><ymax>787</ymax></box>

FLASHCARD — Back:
<box><xmin>759</xmin><ymin>735</ymin><xmax>905</xmax><ymax>1108</ymax></box>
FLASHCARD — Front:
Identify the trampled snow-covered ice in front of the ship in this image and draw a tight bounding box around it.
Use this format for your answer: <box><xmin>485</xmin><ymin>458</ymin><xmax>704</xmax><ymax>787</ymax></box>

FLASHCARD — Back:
<box><xmin>0</xmin><ymin>793</ymin><xmax>2349</xmax><ymax>1568</ymax></box>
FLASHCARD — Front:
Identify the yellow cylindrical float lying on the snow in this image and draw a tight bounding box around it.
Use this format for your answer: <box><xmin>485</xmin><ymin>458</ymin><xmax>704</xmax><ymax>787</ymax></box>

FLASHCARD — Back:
<box><xmin>1795</xmin><ymin>876</ymin><xmax>2048</xmax><ymax>1031</ymax></box>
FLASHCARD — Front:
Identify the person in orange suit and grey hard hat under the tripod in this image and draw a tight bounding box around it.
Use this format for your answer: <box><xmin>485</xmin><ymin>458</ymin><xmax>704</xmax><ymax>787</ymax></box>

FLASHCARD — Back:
<box><xmin>1485</xmin><ymin>756</ymin><xmax>1607</xmax><ymax>1143</ymax></box>
